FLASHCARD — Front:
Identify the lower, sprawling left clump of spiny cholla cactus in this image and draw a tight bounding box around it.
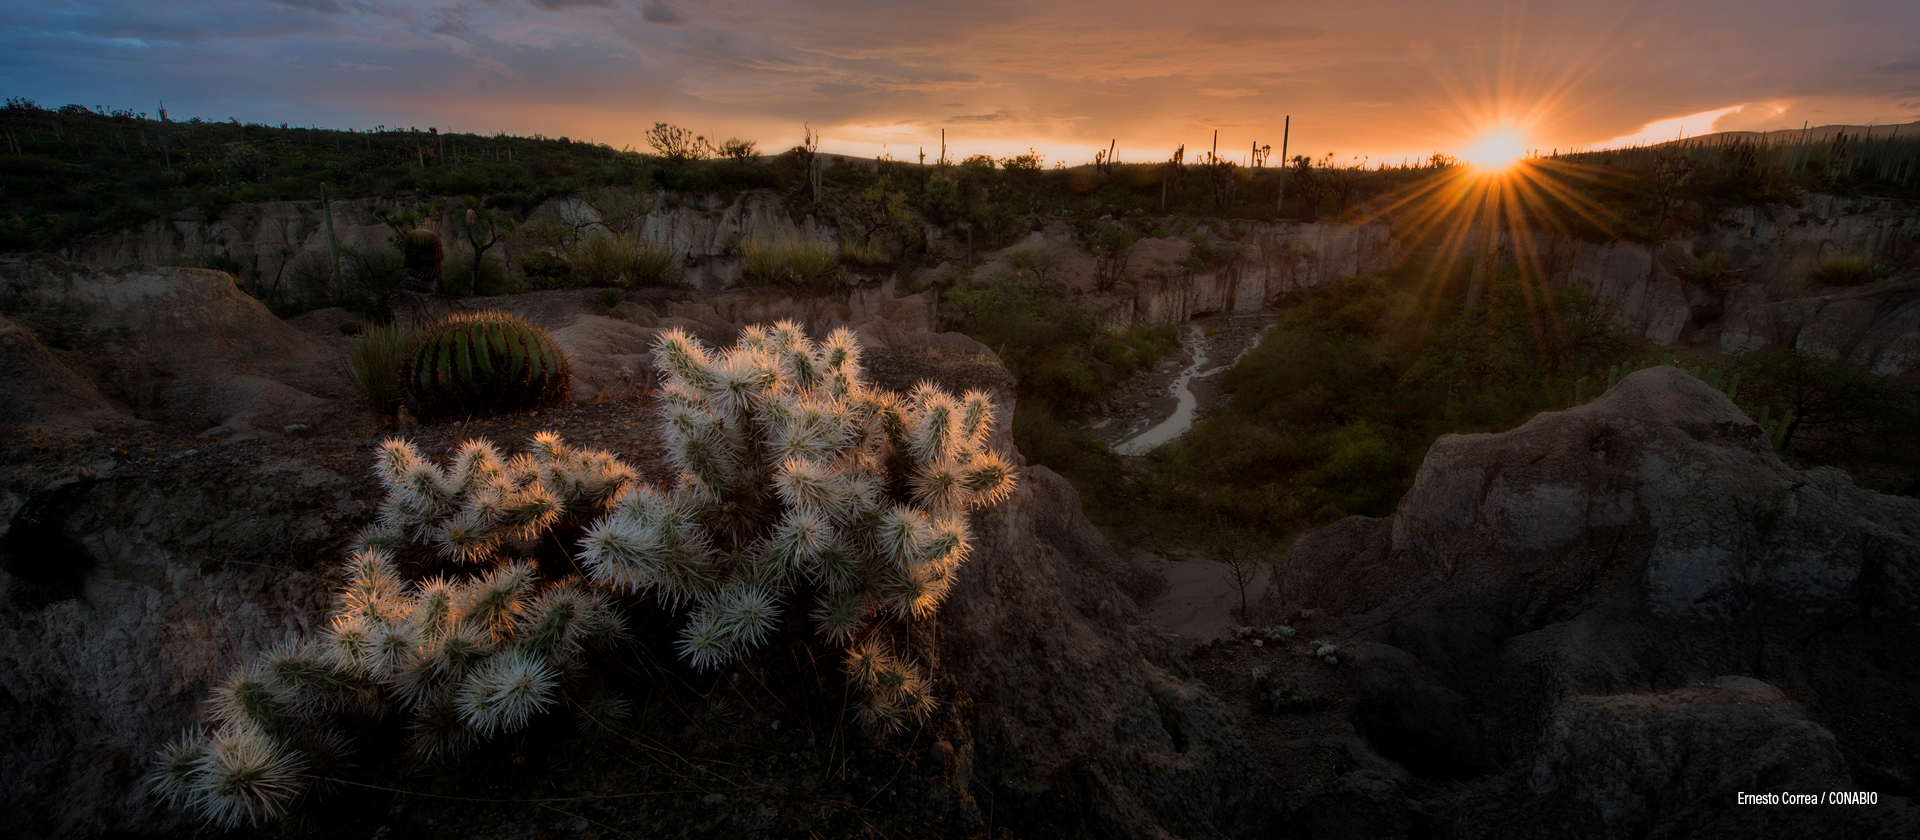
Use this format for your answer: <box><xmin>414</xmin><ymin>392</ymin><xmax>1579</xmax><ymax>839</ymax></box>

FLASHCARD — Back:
<box><xmin>152</xmin><ymin>433</ymin><xmax>634</xmax><ymax>827</ymax></box>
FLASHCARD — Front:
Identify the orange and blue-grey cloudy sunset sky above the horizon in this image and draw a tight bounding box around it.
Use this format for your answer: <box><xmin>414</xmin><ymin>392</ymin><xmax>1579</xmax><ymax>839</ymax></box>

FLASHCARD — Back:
<box><xmin>0</xmin><ymin>0</ymin><xmax>1920</xmax><ymax>163</ymax></box>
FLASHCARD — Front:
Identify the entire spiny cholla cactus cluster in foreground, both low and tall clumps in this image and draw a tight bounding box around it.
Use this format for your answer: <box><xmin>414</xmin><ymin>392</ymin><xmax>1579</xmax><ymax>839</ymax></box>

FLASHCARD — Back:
<box><xmin>152</xmin><ymin>322</ymin><xmax>1016</xmax><ymax>827</ymax></box>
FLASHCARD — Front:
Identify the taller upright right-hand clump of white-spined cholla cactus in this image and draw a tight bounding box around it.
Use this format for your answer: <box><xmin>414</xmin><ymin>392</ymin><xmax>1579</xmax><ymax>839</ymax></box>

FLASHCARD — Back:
<box><xmin>580</xmin><ymin>322</ymin><xmax>1014</xmax><ymax>725</ymax></box>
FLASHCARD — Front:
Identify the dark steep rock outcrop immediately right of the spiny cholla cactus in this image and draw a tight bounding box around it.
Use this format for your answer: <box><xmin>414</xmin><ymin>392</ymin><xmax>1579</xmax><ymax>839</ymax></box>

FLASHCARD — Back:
<box><xmin>941</xmin><ymin>466</ymin><xmax>1250</xmax><ymax>838</ymax></box>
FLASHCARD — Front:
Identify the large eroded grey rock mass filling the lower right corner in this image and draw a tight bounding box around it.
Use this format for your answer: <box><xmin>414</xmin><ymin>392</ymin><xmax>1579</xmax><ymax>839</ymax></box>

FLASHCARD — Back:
<box><xmin>1265</xmin><ymin>368</ymin><xmax>1920</xmax><ymax>836</ymax></box>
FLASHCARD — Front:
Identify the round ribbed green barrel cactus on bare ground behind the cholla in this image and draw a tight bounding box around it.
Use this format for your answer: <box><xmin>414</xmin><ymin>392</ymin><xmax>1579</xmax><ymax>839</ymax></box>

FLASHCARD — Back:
<box><xmin>399</xmin><ymin>313</ymin><xmax>572</xmax><ymax>420</ymax></box>
